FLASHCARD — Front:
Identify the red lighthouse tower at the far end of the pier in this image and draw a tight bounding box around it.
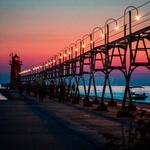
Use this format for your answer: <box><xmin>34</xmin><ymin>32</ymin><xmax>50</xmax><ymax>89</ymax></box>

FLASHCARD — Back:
<box><xmin>10</xmin><ymin>54</ymin><xmax>22</xmax><ymax>88</ymax></box>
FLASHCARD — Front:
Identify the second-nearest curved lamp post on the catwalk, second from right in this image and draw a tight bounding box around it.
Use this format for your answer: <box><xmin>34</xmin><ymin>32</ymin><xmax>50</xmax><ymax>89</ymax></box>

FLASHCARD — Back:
<box><xmin>105</xmin><ymin>18</ymin><xmax>118</xmax><ymax>44</ymax></box>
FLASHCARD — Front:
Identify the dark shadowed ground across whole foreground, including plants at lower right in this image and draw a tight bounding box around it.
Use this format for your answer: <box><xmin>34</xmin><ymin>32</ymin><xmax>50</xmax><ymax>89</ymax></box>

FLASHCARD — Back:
<box><xmin>0</xmin><ymin>90</ymin><xmax>150</xmax><ymax>150</ymax></box>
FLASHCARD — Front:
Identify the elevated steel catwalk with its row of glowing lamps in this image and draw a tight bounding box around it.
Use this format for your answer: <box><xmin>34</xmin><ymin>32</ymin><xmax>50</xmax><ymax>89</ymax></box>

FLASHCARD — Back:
<box><xmin>19</xmin><ymin>2</ymin><xmax>150</xmax><ymax>115</ymax></box>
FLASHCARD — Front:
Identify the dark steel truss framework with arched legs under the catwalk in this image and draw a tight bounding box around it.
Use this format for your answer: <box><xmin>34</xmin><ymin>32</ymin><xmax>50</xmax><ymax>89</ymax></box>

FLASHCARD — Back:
<box><xmin>21</xmin><ymin>23</ymin><xmax>150</xmax><ymax>110</ymax></box>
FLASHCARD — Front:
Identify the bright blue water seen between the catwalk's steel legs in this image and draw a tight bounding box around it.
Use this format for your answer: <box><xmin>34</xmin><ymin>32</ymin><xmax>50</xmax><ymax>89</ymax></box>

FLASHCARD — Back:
<box><xmin>79</xmin><ymin>86</ymin><xmax>150</xmax><ymax>103</ymax></box>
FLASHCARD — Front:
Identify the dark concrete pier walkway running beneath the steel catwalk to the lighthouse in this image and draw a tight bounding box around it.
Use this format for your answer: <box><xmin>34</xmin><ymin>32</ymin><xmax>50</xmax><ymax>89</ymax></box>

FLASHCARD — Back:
<box><xmin>0</xmin><ymin>89</ymin><xmax>141</xmax><ymax>150</ymax></box>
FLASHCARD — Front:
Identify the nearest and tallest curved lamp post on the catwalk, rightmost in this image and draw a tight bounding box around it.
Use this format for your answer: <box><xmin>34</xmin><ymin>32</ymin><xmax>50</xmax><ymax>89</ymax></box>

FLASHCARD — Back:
<box><xmin>124</xmin><ymin>6</ymin><xmax>140</xmax><ymax>36</ymax></box>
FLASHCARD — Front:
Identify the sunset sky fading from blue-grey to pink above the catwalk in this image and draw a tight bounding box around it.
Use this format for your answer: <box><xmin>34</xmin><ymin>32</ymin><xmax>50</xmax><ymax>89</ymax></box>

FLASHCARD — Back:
<box><xmin>0</xmin><ymin>0</ymin><xmax>147</xmax><ymax>83</ymax></box>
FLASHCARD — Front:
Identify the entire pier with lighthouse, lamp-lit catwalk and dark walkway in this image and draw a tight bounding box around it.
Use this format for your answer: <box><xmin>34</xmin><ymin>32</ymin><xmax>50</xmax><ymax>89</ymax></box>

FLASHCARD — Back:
<box><xmin>0</xmin><ymin>1</ymin><xmax>150</xmax><ymax>150</ymax></box>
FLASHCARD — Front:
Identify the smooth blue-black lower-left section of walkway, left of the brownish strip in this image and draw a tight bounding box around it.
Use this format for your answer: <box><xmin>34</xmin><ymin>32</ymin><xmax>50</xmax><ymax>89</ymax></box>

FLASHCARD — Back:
<box><xmin>0</xmin><ymin>89</ymin><xmax>103</xmax><ymax>150</ymax></box>
